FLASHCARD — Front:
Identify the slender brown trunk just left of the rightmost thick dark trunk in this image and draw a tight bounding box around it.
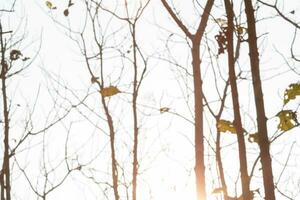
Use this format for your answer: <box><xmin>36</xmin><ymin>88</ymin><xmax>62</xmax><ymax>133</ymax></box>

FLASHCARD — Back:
<box><xmin>225</xmin><ymin>0</ymin><xmax>252</xmax><ymax>200</ymax></box>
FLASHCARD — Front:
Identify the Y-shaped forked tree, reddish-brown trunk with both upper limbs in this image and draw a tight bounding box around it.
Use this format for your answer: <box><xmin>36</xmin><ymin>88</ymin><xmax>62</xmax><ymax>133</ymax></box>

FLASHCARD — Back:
<box><xmin>161</xmin><ymin>0</ymin><xmax>214</xmax><ymax>200</ymax></box>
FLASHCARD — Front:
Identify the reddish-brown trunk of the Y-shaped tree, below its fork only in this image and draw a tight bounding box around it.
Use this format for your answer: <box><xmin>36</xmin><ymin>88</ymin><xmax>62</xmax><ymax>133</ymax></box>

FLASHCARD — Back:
<box><xmin>192</xmin><ymin>40</ymin><xmax>206</xmax><ymax>200</ymax></box>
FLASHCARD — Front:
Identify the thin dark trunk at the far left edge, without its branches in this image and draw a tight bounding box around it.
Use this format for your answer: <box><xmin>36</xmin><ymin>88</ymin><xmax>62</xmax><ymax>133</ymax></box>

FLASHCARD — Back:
<box><xmin>0</xmin><ymin>24</ymin><xmax>11</xmax><ymax>200</ymax></box>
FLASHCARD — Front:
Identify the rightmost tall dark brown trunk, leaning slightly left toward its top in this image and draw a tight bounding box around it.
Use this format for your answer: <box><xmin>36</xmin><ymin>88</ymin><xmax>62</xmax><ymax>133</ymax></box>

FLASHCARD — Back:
<box><xmin>244</xmin><ymin>0</ymin><xmax>275</xmax><ymax>200</ymax></box>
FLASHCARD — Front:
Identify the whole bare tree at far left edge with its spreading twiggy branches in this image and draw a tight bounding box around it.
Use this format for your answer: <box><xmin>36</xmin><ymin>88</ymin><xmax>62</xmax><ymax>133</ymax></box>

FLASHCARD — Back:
<box><xmin>0</xmin><ymin>1</ymin><xmax>81</xmax><ymax>200</ymax></box>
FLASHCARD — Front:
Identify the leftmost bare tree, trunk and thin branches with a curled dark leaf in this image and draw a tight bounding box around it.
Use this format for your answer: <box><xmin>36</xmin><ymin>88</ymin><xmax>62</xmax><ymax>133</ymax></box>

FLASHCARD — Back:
<box><xmin>0</xmin><ymin>1</ymin><xmax>76</xmax><ymax>200</ymax></box>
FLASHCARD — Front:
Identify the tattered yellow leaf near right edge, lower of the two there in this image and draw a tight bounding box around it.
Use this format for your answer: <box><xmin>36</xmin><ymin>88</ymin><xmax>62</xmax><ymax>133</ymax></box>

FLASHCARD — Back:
<box><xmin>276</xmin><ymin>110</ymin><xmax>298</xmax><ymax>131</ymax></box>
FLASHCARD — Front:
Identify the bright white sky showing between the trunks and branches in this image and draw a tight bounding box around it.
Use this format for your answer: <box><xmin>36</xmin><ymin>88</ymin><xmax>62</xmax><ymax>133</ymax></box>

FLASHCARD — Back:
<box><xmin>0</xmin><ymin>0</ymin><xmax>300</xmax><ymax>200</ymax></box>
